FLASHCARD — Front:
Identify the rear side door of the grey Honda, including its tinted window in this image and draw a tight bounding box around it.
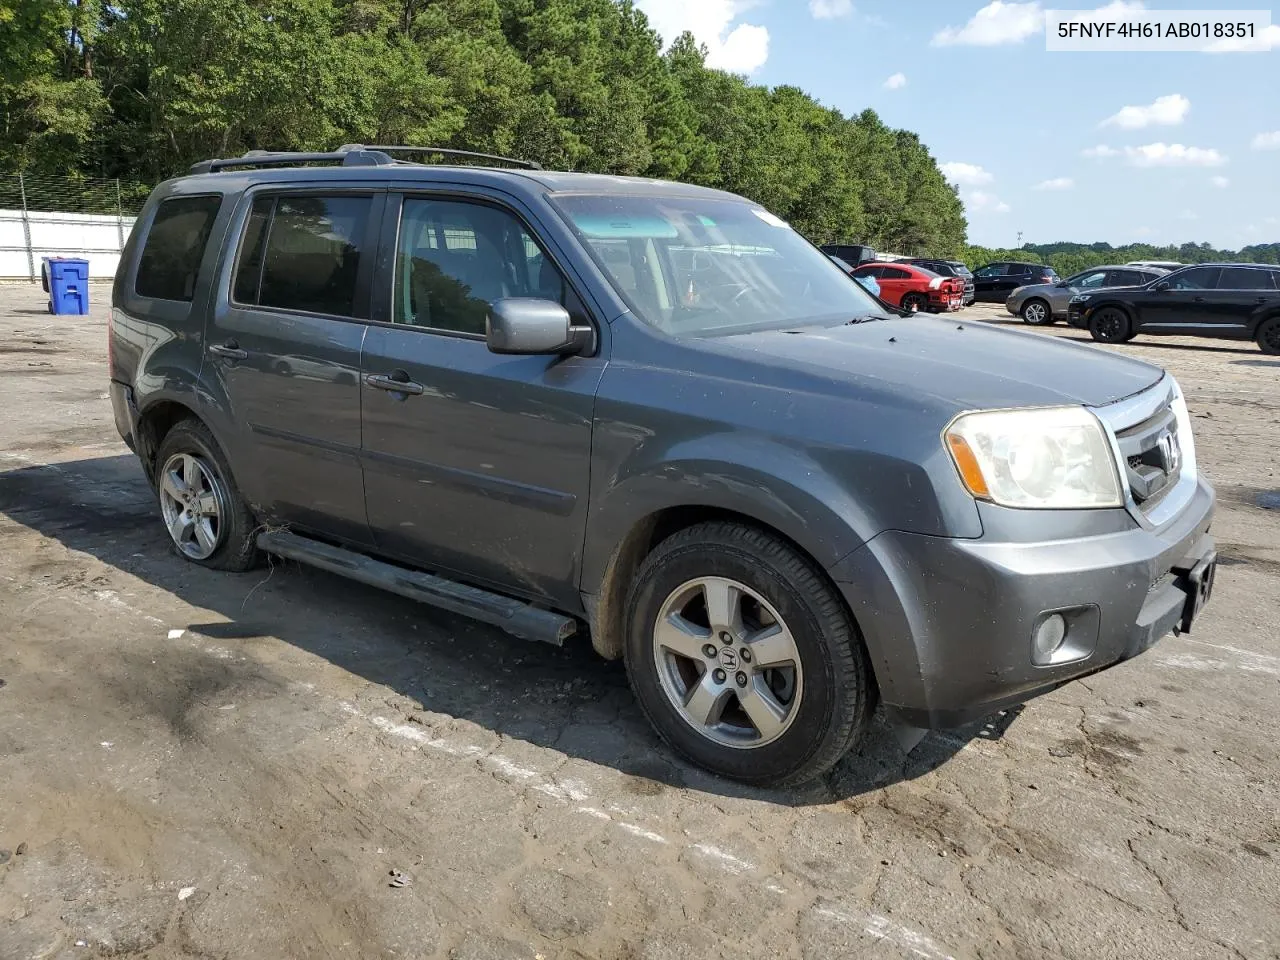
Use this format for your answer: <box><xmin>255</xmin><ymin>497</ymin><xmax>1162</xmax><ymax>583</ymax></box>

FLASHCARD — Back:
<box><xmin>205</xmin><ymin>184</ymin><xmax>384</xmax><ymax>544</ymax></box>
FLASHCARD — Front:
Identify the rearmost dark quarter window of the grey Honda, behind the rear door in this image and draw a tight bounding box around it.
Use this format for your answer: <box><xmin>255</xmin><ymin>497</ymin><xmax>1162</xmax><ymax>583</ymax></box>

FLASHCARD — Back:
<box><xmin>133</xmin><ymin>196</ymin><xmax>223</xmax><ymax>302</ymax></box>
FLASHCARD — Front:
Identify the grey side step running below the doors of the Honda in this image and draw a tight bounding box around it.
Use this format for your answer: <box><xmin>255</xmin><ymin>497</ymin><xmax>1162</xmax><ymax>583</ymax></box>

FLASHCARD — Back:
<box><xmin>257</xmin><ymin>532</ymin><xmax>577</xmax><ymax>646</ymax></box>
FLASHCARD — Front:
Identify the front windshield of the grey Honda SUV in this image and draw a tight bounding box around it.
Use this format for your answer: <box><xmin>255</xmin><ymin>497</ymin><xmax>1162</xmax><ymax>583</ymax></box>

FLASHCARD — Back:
<box><xmin>554</xmin><ymin>195</ymin><xmax>886</xmax><ymax>337</ymax></box>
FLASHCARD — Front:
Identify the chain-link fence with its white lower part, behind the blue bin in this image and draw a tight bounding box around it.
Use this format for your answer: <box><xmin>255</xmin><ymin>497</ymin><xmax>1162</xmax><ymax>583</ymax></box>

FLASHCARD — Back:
<box><xmin>0</xmin><ymin>173</ymin><xmax>151</xmax><ymax>283</ymax></box>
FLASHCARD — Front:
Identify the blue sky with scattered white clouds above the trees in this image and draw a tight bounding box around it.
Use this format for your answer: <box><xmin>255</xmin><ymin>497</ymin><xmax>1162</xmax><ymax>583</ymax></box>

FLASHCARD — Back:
<box><xmin>636</xmin><ymin>0</ymin><xmax>1280</xmax><ymax>250</ymax></box>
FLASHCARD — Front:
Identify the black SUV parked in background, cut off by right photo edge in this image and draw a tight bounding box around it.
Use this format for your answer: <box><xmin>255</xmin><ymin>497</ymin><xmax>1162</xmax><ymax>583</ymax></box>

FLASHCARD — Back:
<box><xmin>1069</xmin><ymin>264</ymin><xmax>1280</xmax><ymax>355</ymax></box>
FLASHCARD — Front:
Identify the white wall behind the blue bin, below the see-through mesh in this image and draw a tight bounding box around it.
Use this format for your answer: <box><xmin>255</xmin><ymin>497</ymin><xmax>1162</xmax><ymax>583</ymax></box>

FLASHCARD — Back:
<box><xmin>0</xmin><ymin>210</ymin><xmax>134</xmax><ymax>280</ymax></box>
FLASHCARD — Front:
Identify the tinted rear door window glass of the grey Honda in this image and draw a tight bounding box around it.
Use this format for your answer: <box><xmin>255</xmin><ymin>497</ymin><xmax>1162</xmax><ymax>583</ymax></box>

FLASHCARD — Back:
<box><xmin>233</xmin><ymin>195</ymin><xmax>372</xmax><ymax>316</ymax></box>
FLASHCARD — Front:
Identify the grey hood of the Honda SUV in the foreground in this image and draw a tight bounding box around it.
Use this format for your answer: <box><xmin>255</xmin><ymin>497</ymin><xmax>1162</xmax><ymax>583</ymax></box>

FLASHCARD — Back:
<box><xmin>704</xmin><ymin>316</ymin><xmax>1164</xmax><ymax>412</ymax></box>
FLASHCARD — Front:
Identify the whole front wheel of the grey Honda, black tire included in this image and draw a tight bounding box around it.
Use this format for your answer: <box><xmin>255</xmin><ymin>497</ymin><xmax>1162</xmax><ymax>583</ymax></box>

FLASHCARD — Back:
<box><xmin>625</xmin><ymin>521</ymin><xmax>876</xmax><ymax>787</ymax></box>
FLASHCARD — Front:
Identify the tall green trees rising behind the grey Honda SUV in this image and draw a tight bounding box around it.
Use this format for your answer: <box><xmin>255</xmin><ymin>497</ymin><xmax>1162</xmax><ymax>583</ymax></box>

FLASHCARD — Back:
<box><xmin>0</xmin><ymin>0</ymin><xmax>965</xmax><ymax>255</ymax></box>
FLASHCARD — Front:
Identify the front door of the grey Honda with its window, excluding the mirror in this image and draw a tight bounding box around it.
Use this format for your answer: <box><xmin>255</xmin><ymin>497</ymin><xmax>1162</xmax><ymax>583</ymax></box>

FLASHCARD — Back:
<box><xmin>361</xmin><ymin>191</ymin><xmax>607</xmax><ymax>608</ymax></box>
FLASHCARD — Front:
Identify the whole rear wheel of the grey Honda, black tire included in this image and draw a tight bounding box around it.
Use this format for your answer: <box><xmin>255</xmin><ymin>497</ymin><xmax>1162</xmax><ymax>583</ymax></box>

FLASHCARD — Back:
<box><xmin>154</xmin><ymin>419</ymin><xmax>259</xmax><ymax>572</ymax></box>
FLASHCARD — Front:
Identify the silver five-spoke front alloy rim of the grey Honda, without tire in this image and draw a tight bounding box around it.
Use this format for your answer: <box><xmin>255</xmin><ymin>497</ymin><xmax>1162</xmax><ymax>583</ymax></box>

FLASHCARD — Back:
<box><xmin>653</xmin><ymin>577</ymin><xmax>804</xmax><ymax>749</ymax></box>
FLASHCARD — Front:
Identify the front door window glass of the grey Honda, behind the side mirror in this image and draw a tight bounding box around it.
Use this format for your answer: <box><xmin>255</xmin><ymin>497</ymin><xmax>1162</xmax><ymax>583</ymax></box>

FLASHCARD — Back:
<box><xmin>393</xmin><ymin>198</ymin><xmax>589</xmax><ymax>337</ymax></box>
